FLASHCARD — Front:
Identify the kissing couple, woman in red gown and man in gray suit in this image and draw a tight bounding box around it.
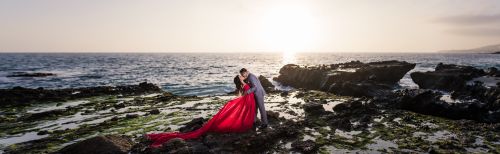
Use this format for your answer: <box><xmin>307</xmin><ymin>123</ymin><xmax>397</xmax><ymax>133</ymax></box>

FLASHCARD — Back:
<box><xmin>146</xmin><ymin>68</ymin><xmax>268</xmax><ymax>147</ymax></box>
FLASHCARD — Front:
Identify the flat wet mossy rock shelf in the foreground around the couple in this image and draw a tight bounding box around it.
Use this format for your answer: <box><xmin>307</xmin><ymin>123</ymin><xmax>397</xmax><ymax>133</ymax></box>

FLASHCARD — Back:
<box><xmin>0</xmin><ymin>90</ymin><xmax>500</xmax><ymax>153</ymax></box>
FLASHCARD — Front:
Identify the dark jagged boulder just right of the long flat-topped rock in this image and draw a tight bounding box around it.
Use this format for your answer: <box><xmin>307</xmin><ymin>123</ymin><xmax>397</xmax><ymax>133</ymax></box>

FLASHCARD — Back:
<box><xmin>410</xmin><ymin>63</ymin><xmax>486</xmax><ymax>91</ymax></box>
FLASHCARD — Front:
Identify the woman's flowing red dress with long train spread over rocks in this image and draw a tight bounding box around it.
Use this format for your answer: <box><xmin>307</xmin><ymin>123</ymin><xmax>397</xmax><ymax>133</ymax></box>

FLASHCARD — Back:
<box><xmin>147</xmin><ymin>84</ymin><xmax>256</xmax><ymax>147</ymax></box>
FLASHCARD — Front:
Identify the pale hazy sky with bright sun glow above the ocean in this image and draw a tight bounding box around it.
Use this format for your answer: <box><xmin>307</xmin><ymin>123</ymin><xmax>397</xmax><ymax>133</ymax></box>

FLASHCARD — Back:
<box><xmin>0</xmin><ymin>0</ymin><xmax>500</xmax><ymax>52</ymax></box>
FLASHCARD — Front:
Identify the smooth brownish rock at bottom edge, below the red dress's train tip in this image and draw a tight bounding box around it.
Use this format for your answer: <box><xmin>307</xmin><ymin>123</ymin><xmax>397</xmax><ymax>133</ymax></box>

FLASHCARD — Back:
<box><xmin>56</xmin><ymin>135</ymin><xmax>134</xmax><ymax>154</ymax></box>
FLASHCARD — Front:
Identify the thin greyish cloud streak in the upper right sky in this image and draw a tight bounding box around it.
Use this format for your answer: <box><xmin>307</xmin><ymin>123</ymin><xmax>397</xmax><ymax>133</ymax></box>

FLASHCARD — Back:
<box><xmin>437</xmin><ymin>14</ymin><xmax>500</xmax><ymax>25</ymax></box>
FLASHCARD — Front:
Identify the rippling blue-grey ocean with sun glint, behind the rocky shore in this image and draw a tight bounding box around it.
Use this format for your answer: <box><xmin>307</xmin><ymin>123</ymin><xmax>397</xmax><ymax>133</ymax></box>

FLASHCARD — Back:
<box><xmin>0</xmin><ymin>53</ymin><xmax>500</xmax><ymax>96</ymax></box>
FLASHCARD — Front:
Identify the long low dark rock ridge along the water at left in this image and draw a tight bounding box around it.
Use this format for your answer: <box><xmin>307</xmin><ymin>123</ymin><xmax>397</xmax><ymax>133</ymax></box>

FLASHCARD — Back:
<box><xmin>0</xmin><ymin>82</ymin><xmax>162</xmax><ymax>106</ymax></box>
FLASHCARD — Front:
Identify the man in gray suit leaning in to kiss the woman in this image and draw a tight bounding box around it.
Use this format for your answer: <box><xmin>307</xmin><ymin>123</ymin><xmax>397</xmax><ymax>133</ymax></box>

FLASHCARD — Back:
<box><xmin>240</xmin><ymin>68</ymin><xmax>268</xmax><ymax>129</ymax></box>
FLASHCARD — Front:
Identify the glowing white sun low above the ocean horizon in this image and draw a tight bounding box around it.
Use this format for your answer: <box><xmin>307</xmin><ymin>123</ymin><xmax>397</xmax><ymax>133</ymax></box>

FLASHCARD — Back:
<box><xmin>259</xmin><ymin>5</ymin><xmax>316</xmax><ymax>53</ymax></box>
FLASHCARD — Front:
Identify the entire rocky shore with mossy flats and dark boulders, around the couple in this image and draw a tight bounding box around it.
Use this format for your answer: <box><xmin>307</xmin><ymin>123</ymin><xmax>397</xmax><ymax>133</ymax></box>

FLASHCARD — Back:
<box><xmin>0</xmin><ymin>61</ymin><xmax>500</xmax><ymax>154</ymax></box>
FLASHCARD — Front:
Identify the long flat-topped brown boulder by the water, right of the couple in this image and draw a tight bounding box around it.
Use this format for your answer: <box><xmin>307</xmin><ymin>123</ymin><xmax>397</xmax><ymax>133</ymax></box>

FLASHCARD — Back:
<box><xmin>274</xmin><ymin>61</ymin><xmax>415</xmax><ymax>97</ymax></box>
